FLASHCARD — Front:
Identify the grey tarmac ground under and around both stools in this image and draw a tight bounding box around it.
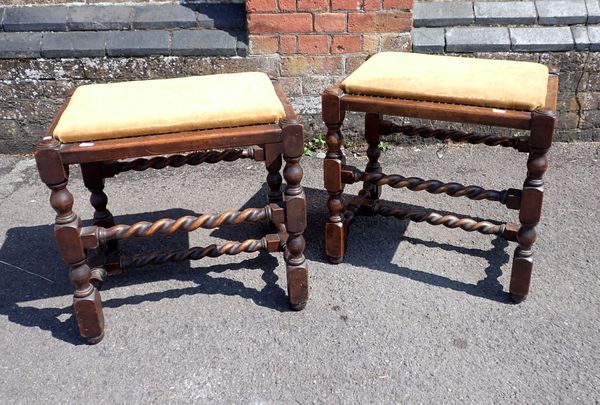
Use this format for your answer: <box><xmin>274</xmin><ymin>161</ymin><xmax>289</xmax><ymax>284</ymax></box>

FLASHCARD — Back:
<box><xmin>0</xmin><ymin>143</ymin><xmax>600</xmax><ymax>404</ymax></box>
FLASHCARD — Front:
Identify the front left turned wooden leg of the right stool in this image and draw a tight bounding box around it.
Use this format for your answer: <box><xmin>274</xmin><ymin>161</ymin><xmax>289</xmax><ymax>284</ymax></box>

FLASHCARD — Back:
<box><xmin>322</xmin><ymin>87</ymin><xmax>347</xmax><ymax>263</ymax></box>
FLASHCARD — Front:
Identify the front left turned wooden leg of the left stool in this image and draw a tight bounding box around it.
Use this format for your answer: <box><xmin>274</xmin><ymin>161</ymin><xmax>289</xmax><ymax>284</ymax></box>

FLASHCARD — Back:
<box><xmin>35</xmin><ymin>139</ymin><xmax>104</xmax><ymax>344</ymax></box>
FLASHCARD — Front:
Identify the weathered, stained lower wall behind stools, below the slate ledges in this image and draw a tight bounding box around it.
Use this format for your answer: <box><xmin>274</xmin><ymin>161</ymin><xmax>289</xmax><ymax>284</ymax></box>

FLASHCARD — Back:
<box><xmin>0</xmin><ymin>51</ymin><xmax>600</xmax><ymax>153</ymax></box>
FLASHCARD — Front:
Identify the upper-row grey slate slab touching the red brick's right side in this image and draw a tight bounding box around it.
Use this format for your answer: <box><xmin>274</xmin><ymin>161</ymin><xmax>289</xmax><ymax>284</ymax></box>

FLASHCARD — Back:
<box><xmin>413</xmin><ymin>1</ymin><xmax>475</xmax><ymax>27</ymax></box>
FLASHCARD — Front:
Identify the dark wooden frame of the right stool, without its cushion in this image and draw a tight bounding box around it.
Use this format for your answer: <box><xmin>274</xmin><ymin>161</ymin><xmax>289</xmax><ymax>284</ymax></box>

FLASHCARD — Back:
<box><xmin>322</xmin><ymin>73</ymin><xmax>558</xmax><ymax>302</ymax></box>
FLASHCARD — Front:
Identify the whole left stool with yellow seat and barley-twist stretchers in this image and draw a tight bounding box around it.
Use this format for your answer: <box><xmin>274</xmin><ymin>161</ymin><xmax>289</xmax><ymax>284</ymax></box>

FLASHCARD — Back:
<box><xmin>35</xmin><ymin>72</ymin><xmax>308</xmax><ymax>343</ymax></box>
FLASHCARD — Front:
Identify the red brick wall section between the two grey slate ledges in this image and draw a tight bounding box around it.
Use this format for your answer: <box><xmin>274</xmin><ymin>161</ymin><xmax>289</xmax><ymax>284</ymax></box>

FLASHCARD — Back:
<box><xmin>246</xmin><ymin>0</ymin><xmax>413</xmax><ymax>55</ymax></box>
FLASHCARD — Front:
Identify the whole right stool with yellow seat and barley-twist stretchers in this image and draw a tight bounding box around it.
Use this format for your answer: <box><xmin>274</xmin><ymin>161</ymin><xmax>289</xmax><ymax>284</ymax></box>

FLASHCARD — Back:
<box><xmin>323</xmin><ymin>52</ymin><xmax>558</xmax><ymax>302</ymax></box>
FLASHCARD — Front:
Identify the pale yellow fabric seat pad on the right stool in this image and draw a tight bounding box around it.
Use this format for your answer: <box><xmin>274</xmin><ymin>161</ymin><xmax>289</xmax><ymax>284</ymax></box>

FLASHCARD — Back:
<box><xmin>342</xmin><ymin>52</ymin><xmax>548</xmax><ymax>111</ymax></box>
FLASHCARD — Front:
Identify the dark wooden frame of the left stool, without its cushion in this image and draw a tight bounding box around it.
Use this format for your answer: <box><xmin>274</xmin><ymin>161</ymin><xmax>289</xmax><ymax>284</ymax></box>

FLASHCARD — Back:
<box><xmin>35</xmin><ymin>82</ymin><xmax>308</xmax><ymax>344</ymax></box>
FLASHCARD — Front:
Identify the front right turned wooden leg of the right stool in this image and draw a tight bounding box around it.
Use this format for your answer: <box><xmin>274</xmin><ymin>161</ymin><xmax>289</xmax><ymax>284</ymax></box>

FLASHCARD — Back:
<box><xmin>510</xmin><ymin>110</ymin><xmax>555</xmax><ymax>302</ymax></box>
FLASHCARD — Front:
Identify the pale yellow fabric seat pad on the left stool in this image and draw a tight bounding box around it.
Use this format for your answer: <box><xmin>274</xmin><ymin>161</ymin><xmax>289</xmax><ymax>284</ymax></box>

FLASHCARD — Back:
<box><xmin>54</xmin><ymin>72</ymin><xmax>285</xmax><ymax>142</ymax></box>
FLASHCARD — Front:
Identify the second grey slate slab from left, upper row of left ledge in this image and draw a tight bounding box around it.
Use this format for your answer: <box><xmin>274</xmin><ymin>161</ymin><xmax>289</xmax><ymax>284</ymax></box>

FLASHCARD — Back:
<box><xmin>67</xmin><ymin>5</ymin><xmax>133</xmax><ymax>31</ymax></box>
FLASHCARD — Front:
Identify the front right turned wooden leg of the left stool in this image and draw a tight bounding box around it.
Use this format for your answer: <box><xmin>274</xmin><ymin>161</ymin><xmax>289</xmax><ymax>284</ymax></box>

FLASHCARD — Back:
<box><xmin>282</xmin><ymin>121</ymin><xmax>308</xmax><ymax>311</ymax></box>
